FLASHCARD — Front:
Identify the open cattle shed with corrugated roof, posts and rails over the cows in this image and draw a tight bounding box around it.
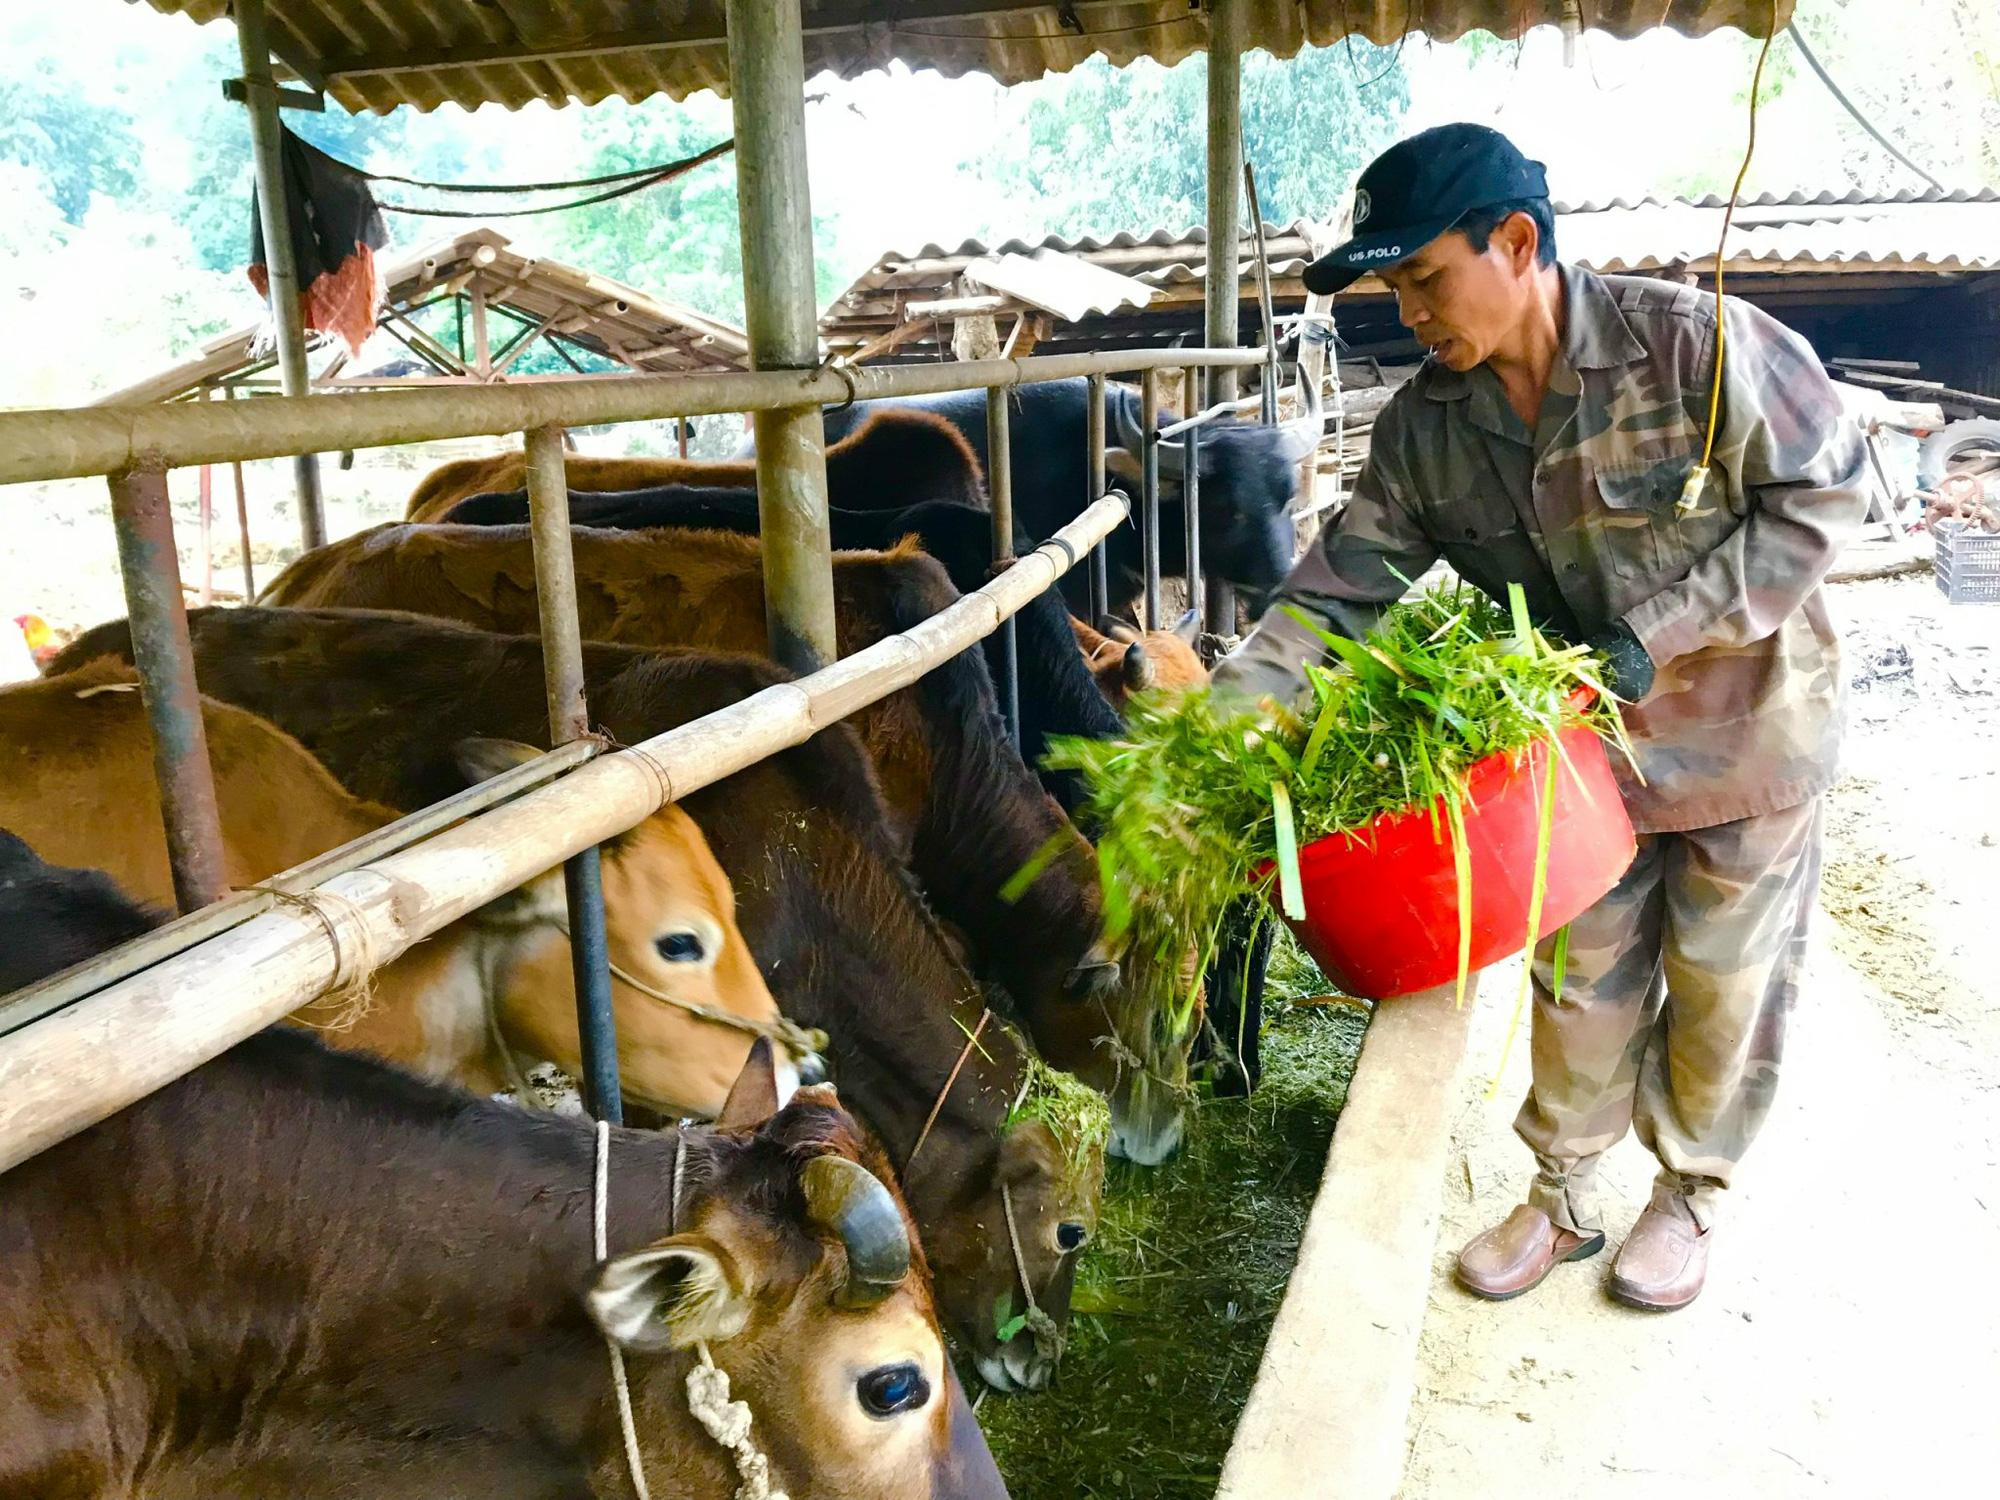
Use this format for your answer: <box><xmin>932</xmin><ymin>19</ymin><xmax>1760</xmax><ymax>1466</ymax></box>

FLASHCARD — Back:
<box><xmin>11</xmin><ymin>0</ymin><xmax>1792</xmax><ymax>1494</ymax></box>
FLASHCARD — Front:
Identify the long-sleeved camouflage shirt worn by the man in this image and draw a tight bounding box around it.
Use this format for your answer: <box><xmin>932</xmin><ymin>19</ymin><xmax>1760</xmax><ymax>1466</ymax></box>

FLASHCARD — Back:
<box><xmin>1216</xmin><ymin>266</ymin><xmax>1868</xmax><ymax>834</ymax></box>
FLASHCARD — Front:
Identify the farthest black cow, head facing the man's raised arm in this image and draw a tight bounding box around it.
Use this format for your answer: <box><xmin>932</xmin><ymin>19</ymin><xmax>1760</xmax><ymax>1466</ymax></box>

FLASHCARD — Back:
<box><xmin>804</xmin><ymin>378</ymin><xmax>1316</xmax><ymax>612</ymax></box>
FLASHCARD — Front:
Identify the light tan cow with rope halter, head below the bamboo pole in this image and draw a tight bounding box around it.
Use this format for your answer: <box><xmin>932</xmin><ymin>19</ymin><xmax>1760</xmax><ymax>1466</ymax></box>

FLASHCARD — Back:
<box><xmin>0</xmin><ymin>660</ymin><xmax>796</xmax><ymax>1114</ymax></box>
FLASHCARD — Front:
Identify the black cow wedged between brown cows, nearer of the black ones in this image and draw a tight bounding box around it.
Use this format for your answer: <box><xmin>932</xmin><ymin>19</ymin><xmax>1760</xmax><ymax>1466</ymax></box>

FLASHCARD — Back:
<box><xmin>444</xmin><ymin>484</ymin><xmax>1146</xmax><ymax>812</ymax></box>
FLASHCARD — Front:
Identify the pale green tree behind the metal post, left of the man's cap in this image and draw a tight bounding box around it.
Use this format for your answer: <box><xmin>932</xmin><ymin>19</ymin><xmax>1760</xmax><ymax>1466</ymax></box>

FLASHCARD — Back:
<box><xmin>966</xmin><ymin>42</ymin><xmax>1410</xmax><ymax>236</ymax></box>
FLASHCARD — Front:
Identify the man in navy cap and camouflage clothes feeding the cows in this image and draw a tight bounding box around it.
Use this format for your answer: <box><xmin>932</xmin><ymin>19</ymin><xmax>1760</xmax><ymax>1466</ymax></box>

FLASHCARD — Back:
<box><xmin>1214</xmin><ymin>124</ymin><xmax>1866</xmax><ymax>1310</ymax></box>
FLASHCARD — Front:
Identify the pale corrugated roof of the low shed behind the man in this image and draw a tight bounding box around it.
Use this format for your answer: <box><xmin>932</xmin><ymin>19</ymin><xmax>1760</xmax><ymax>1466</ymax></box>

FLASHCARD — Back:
<box><xmin>820</xmin><ymin>190</ymin><xmax>2000</xmax><ymax>358</ymax></box>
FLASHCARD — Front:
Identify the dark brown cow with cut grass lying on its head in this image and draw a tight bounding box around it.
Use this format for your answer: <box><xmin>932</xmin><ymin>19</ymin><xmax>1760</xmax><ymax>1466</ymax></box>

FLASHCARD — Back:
<box><xmin>56</xmin><ymin>608</ymin><xmax>1098</xmax><ymax>1388</ymax></box>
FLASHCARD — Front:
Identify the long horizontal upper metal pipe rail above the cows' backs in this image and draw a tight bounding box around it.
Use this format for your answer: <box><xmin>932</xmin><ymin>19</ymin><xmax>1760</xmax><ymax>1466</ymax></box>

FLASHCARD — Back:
<box><xmin>0</xmin><ymin>350</ymin><xmax>1262</xmax><ymax>484</ymax></box>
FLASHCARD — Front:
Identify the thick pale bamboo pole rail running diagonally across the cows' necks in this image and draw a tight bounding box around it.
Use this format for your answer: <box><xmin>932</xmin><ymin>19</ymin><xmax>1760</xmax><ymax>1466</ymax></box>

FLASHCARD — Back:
<box><xmin>0</xmin><ymin>496</ymin><xmax>1126</xmax><ymax>1172</ymax></box>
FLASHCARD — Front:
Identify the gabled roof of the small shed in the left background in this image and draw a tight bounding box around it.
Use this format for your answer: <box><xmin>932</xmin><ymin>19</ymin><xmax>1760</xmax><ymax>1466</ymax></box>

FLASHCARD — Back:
<box><xmin>96</xmin><ymin>228</ymin><xmax>750</xmax><ymax>406</ymax></box>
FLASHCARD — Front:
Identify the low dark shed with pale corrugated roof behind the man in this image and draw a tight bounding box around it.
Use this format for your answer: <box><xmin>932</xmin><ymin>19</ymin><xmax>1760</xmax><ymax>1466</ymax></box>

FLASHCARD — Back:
<box><xmin>820</xmin><ymin>188</ymin><xmax>2000</xmax><ymax>396</ymax></box>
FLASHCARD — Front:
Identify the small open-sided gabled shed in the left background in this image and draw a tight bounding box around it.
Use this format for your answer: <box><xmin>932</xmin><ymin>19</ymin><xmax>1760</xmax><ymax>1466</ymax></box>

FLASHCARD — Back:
<box><xmin>98</xmin><ymin>228</ymin><xmax>750</xmax><ymax>406</ymax></box>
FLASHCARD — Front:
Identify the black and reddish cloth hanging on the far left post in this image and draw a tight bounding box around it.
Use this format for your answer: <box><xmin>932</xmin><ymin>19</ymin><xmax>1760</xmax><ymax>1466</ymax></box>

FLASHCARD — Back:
<box><xmin>250</xmin><ymin>126</ymin><xmax>388</xmax><ymax>354</ymax></box>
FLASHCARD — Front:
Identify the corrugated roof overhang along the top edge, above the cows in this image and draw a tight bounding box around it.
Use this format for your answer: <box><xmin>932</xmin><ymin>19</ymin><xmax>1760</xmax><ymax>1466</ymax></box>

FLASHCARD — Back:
<box><xmin>133</xmin><ymin>0</ymin><xmax>1792</xmax><ymax>112</ymax></box>
